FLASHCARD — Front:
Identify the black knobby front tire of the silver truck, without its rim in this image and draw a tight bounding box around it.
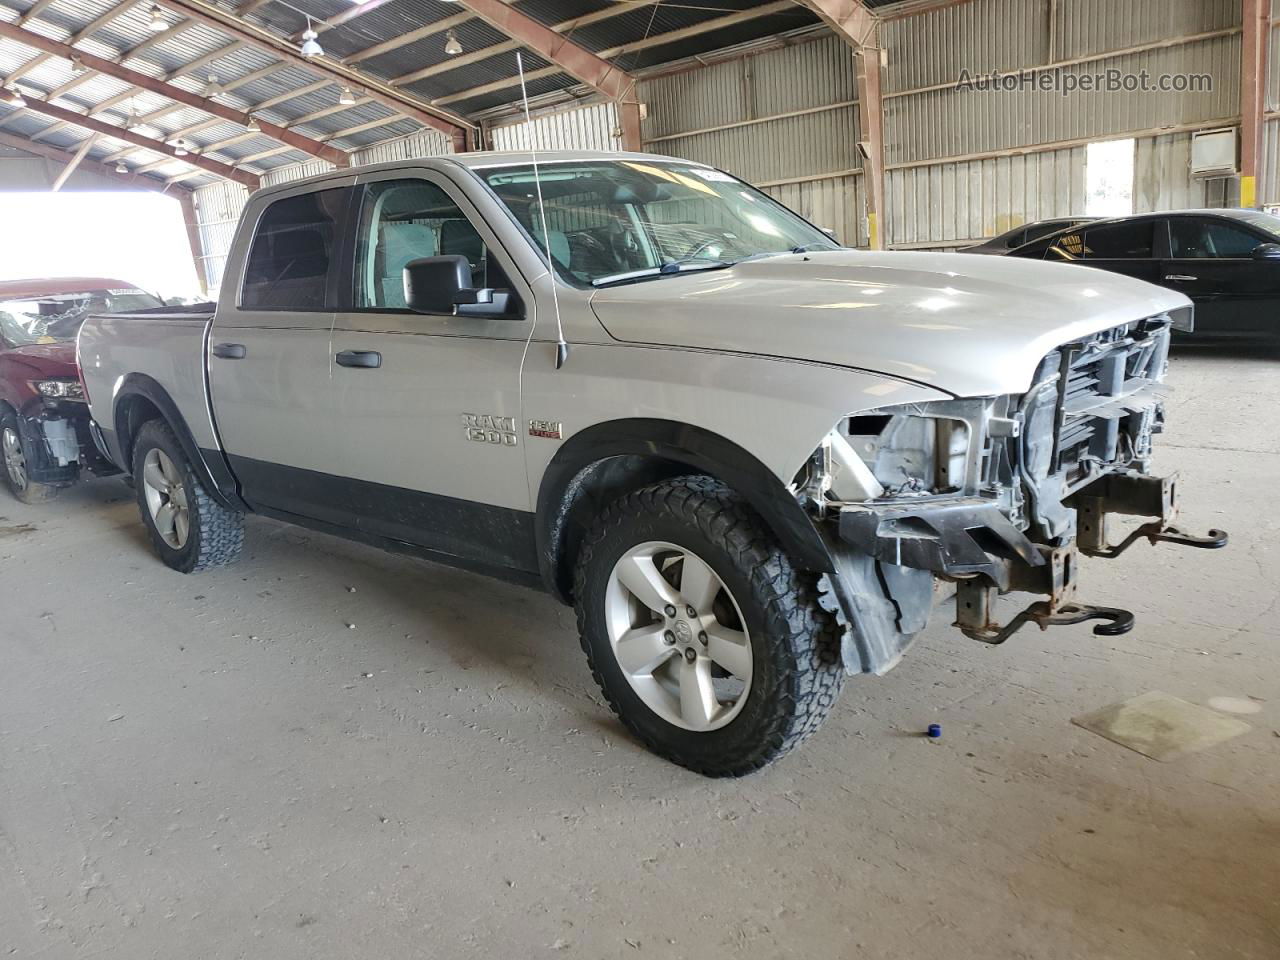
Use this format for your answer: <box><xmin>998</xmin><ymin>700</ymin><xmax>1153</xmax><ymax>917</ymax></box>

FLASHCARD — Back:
<box><xmin>575</xmin><ymin>476</ymin><xmax>845</xmax><ymax>777</ymax></box>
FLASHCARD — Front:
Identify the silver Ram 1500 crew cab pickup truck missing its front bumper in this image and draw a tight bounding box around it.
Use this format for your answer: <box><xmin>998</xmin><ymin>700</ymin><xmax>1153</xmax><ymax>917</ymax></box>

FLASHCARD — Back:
<box><xmin>79</xmin><ymin>152</ymin><xmax>1226</xmax><ymax>776</ymax></box>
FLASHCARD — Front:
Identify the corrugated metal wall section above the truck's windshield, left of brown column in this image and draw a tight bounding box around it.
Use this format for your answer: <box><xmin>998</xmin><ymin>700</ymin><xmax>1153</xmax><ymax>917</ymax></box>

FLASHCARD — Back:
<box><xmin>640</xmin><ymin>36</ymin><xmax>865</xmax><ymax>243</ymax></box>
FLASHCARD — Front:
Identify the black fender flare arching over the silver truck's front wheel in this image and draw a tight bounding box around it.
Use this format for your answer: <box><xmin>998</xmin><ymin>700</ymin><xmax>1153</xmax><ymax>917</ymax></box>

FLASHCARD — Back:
<box><xmin>535</xmin><ymin>417</ymin><xmax>835</xmax><ymax>603</ymax></box>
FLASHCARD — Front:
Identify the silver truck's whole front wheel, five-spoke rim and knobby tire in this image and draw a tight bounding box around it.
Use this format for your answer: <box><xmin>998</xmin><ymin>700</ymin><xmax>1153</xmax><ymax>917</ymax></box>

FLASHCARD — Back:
<box><xmin>575</xmin><ymin>476</ymin><xmax>844</xmax><ymax>777</ymax></box>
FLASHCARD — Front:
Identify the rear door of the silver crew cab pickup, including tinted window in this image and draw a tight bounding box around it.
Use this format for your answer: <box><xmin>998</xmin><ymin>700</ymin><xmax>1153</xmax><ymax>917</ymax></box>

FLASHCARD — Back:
<box><xmin>207</xmin><ymin>178</ymin><xmax>355</xmax><ymax>517</ymax></box>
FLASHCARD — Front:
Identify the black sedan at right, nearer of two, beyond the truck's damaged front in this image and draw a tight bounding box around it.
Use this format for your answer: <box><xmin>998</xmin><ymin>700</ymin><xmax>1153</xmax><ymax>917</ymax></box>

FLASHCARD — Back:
<box><xmin>1007</xmin><ymin>210</ymin><xmax>1280</xmax><ymax>339</ymax></box>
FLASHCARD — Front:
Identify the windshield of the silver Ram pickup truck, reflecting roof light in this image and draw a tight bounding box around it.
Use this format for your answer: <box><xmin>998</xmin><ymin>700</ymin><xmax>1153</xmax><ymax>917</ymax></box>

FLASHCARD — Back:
<box><xmin>477</xmin><ymin>160</ymin><xmax>840</xmax><ymax>287</ymax></box>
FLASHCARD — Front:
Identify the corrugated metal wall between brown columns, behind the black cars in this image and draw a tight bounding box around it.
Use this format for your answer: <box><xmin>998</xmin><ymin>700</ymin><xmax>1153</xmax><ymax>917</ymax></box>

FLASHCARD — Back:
<box><xmin>882</xmin><ymin>0</ymin><xmax>1244</xmax><ymax>246</ymax></box>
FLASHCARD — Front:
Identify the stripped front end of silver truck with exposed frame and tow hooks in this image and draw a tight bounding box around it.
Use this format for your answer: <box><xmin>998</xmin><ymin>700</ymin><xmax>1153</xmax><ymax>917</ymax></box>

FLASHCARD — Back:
<box><xmin>797</xmin><ymin>315</ymin><xmax>1226</xmax><ymax>673</ymax></box>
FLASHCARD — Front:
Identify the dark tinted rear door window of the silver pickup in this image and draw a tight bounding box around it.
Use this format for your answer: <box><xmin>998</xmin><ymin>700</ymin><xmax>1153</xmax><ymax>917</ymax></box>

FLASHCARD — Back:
<box><xmin>241</xmin><ymin>187</ymin><xmax>347</xmax><ymax>316</ymax></box>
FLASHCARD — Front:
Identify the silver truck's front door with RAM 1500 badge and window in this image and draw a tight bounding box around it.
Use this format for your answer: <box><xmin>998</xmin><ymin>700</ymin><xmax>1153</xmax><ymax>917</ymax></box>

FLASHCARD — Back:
<box><xmin>328</xmin><ymin>172</ymin><xmax>538</xmax><ymax>572</ymax></box>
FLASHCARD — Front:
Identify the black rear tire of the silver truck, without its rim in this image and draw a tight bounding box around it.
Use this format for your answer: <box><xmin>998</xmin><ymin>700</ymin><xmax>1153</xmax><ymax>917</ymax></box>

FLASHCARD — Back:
<box><xmin>133</xmin><ymin>420</ymin><xmax>244</xmax><ymax>573</ymax></box>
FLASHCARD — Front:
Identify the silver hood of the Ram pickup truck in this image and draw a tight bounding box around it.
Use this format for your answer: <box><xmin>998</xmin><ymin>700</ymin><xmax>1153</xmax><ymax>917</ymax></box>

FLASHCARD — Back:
<box><xmin>591</xmin><ymin>250</ymin><xmax>1190</xmax><ymax>397</ymax></box>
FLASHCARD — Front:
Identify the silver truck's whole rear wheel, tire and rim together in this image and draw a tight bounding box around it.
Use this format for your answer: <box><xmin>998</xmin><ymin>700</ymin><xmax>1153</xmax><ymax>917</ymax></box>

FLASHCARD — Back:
<box><xmin>133</xmin><ymin>420</ymin><xmax>244</xmax><ymax>573</ymax></box>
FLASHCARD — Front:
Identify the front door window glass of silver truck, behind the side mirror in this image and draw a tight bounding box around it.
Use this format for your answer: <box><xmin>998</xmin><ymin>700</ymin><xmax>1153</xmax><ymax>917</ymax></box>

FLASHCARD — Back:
<box><xmin>356</xmin><ymin>180</ymin><xmax>494</xmax><ymax>310</ymax></box>
